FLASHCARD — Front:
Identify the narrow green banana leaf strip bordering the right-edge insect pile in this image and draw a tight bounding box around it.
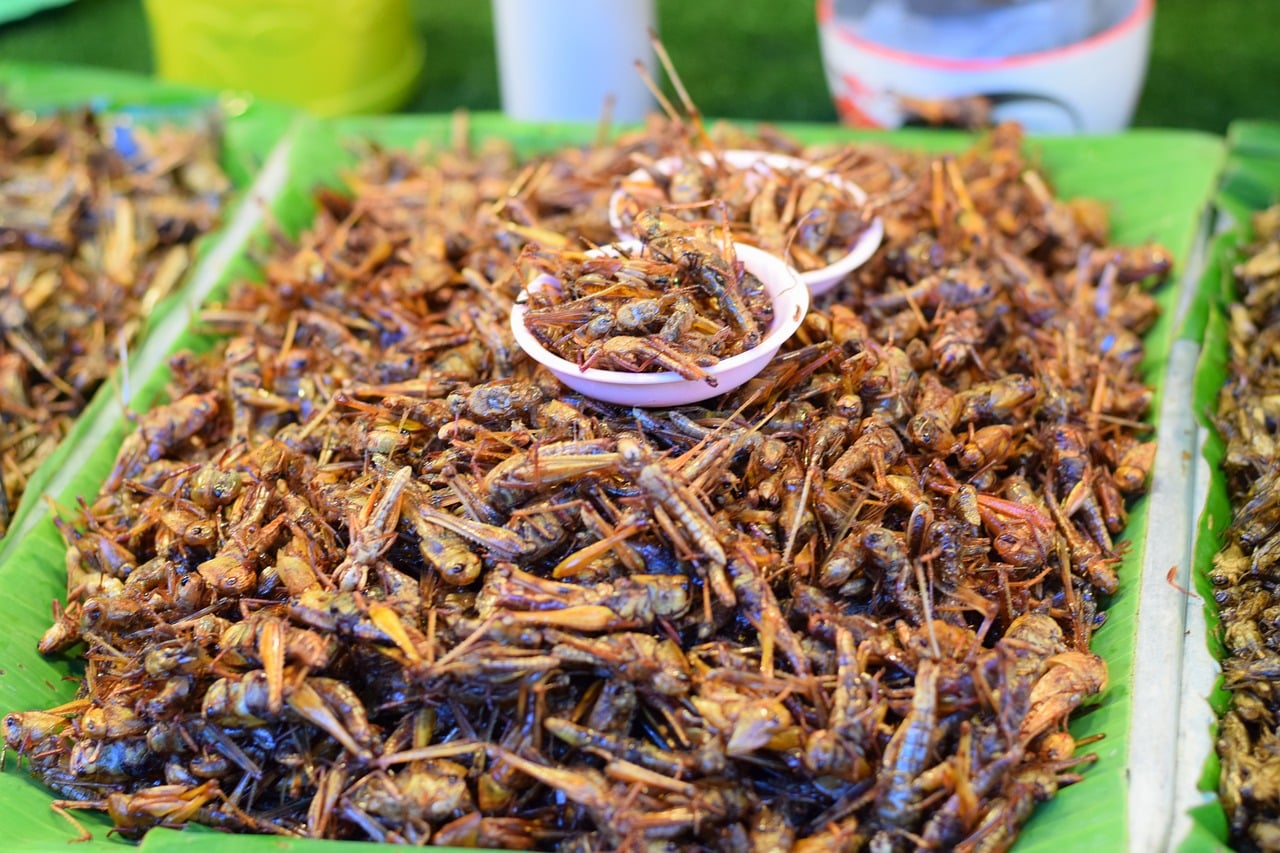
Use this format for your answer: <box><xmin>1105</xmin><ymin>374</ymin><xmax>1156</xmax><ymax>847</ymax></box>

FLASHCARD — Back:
<box><xmin>1178</xmin><ymin>122</ymin><xmax>1280</xmax><ymax>853</ymax></box>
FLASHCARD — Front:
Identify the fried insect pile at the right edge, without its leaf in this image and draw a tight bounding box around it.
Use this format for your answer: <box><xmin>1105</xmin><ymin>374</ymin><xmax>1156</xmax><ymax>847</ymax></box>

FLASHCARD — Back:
<box><xmin>1210</xmin><ymin>206</ymin><xmax>1280</xmax><ymax>850</ymax></box>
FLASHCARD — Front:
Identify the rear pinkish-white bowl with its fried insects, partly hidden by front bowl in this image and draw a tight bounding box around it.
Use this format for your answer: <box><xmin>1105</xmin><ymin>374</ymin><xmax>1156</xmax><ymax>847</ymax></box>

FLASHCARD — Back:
<box><xmin>609</xmin><ymin>149</ymin><xmax>884</xmax><ymax>296</ymax></box>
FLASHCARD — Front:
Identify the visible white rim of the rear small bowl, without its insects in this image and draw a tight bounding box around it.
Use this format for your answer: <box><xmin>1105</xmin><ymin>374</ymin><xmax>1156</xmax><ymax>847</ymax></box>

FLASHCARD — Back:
<box><xmin>609</xmin><ymin>149</ymin><xmax>884</xmax><ymax>296</ymax></box>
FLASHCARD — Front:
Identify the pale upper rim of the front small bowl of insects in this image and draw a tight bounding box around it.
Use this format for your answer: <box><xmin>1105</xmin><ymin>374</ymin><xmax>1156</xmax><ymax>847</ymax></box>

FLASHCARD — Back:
<box><xmin>511</xmin><ymin>240</ymin><xmax>809</xmax><ymax>396</ymax></box>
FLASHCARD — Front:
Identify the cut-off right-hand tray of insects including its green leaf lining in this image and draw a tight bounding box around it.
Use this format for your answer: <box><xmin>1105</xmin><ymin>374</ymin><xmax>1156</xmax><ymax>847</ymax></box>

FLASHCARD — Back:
<box><xmin>1180</xmin><ymin>122</ymin><xmax>1280</xmax><ymax>850</ymax></box>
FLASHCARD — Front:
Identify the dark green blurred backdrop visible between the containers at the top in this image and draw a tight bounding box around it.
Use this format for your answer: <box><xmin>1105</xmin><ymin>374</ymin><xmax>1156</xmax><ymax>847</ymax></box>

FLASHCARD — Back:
<box><xmin>0</xmin><ymin>0</ymin><xmax>1280</xmax><ymax>133</ymax></box>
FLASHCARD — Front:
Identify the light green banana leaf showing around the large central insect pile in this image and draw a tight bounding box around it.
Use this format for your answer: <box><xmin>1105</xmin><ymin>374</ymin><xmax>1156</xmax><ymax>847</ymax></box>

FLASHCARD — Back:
<box><xmin>0</xmin><ymin>87</ymin><xmax>1224</xmax><ymax>853</ymax></box>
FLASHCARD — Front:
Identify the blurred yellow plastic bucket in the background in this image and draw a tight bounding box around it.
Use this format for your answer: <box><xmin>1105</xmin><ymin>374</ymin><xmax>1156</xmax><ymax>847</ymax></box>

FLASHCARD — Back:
<box><xmin>143</xmin><ymin>0</ymin><xmax>425</xmax><ymax>115</ymax></box>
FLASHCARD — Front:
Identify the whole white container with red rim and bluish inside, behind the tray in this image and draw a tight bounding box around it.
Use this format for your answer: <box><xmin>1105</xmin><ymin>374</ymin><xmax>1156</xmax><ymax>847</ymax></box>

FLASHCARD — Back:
<box><xmin>817</xmin><ymin>0</ymin><xmax>1156</xmax><ymax>133</ymax></box>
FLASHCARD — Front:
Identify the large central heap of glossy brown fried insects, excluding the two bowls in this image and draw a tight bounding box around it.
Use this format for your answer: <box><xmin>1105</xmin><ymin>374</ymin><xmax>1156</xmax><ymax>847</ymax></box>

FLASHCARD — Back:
<box><xmin>4</xmin><ymin>115</ymin><xmax>1170</xmax><ymax>852</ymax></box>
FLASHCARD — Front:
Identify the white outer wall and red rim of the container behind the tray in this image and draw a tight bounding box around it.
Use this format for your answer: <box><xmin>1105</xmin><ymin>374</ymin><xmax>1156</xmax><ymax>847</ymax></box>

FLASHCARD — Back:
<box><xmin>817</xmin><ymin>0</ymin><xmax>1155</xmax><ymax>133</ymax></box>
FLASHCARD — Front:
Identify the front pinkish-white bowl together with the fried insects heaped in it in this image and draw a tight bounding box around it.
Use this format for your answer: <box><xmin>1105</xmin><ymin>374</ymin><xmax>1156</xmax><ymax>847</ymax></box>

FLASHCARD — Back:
<box><xmin>511</xmin><ymin>231</ymin><xmax>809</xmax><ymax>406</ymax></box>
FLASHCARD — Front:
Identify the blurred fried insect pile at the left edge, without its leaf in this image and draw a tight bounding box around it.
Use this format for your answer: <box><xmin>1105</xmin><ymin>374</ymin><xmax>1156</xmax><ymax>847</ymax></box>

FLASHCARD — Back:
<box><xmin>0</xmin><ymin>109</ymin><xmax>229</xmax><ymax>538</ymax></box>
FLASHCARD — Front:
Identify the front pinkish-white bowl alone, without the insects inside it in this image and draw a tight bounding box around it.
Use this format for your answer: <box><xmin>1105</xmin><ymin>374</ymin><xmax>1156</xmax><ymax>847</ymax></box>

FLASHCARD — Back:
<box><xmin>511</xmin><ymin>241</ymin><xmax>809</xmax><ymax>407</ymax></box>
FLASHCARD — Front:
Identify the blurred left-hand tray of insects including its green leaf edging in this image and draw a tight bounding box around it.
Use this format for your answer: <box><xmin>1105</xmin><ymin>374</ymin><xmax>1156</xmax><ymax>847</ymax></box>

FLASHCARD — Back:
<box><xmin>0</xmin><ymin>67</ymin><xmax>284</xmax><ymax>548</ymax></box>
